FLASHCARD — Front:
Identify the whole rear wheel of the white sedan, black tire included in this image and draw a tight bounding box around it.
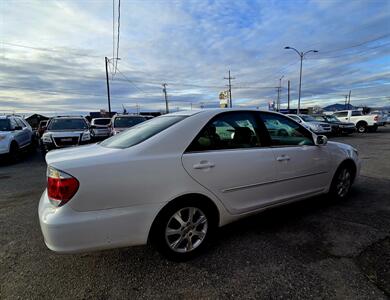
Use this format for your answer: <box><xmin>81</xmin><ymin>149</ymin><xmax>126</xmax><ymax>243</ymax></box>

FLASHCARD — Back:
<box><xmin>150</xmin><ymin>199</ymin><xmax>217</xmax><ymax>261</ymax></box>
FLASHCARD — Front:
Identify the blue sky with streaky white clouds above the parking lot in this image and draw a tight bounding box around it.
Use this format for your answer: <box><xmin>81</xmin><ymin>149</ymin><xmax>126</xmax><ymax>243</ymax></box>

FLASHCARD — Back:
<box><xmin>0</xmin><ymin>0</ymin><xmax>390</xmax><ymax>113</ymax></box>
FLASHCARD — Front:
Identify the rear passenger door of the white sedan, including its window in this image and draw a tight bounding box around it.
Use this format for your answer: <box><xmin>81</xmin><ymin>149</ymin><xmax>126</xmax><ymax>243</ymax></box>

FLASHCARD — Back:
<box><xmin>182</xmin><ymin>111</ymin><xmax>277</xmax><ymax>214</ymax></box>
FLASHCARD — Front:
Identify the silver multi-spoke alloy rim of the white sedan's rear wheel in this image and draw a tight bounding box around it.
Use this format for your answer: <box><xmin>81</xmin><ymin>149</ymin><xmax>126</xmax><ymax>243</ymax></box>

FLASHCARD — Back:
<box><xmin>165</xmin><ymin>207</ymin><xmax>208</xmax><ymax>253</ymax></box>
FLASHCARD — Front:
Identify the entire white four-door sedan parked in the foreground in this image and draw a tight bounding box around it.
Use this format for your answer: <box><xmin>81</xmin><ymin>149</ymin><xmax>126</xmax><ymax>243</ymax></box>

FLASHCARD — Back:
<box><xmin>39</xmin><ymin>109</ymin><xmax>360</xmax><ymax>260</ymax></box>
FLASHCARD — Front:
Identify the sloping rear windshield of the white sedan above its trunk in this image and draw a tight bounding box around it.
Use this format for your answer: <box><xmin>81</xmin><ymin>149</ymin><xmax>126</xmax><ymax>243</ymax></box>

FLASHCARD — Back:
<box><xmin>100</xmin><ymin>116</ymin><xmax>186</xmax><ymax>149</ymax></box>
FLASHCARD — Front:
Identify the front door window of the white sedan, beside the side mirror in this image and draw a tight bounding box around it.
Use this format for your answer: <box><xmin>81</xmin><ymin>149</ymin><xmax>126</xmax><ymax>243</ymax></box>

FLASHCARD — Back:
<box><xmin>260</xmin><ymin>113</ymin><xmax>314</xmax><ymax>146</ymax></box>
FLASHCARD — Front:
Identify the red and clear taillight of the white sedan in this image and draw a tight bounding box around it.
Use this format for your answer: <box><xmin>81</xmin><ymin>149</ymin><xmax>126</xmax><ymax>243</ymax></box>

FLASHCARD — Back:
<box><xmin>47</xmin><ymin>167</ymin><xmax>79</xmax><ymax>206</ymax></box>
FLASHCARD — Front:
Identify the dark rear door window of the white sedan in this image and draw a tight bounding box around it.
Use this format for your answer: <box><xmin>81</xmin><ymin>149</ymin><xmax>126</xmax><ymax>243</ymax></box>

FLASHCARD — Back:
<box><xmin>187</xmin><ymin>112</ymin><xmax>261</xmax><ymax>152</ymax></box>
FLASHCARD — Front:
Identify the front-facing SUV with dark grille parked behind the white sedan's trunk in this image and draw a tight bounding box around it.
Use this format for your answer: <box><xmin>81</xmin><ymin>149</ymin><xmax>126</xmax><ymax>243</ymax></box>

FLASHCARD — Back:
<box><xmin>41</xmin><ymin>116</ymin><xmax>91</xmax><ymax>153</ymax></box>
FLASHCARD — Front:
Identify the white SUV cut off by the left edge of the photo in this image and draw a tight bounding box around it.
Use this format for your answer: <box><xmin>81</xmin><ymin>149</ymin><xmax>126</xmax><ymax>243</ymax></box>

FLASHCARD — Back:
<box><xmin>0</xmin><ymin>115</ymin><xmax>34</xmax><ymax>158</ymax></box>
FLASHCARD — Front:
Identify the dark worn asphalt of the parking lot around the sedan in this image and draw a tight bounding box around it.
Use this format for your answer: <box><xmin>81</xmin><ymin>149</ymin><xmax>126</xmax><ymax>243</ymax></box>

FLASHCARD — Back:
<box><xmin>0</xmin><ymin>127</ymin><xmax>390</xmax><ymax>299</ymax></box>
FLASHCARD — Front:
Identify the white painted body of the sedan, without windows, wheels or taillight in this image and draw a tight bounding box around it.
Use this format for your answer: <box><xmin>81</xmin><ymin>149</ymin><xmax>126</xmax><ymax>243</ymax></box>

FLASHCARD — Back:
<box><xmin>39</xmin><ymin>109</ymin><xmax>360</xmax><ymax>253</ymax></box>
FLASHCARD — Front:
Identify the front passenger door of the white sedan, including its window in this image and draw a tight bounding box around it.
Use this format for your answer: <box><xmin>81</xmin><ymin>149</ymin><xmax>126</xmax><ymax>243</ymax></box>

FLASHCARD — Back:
<box><xmin>259</xmin><ymin>112</ymin><xmax>329</xmax><ymax>200</ymax></box>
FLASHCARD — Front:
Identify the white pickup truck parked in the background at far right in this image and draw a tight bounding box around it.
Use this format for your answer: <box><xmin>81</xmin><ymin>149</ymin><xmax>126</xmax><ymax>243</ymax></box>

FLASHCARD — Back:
<box><xmin>333</xmin><ymin>110</ymin><xmax>379</xmax><ymax>133</ymax></box>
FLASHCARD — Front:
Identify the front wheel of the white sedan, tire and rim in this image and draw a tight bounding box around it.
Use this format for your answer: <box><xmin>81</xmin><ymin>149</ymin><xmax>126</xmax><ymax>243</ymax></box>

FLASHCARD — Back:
<box><xmin>329</xmin><ymin>163</ymin><xmax>354</xmax><ymax>200</ymax></box>
